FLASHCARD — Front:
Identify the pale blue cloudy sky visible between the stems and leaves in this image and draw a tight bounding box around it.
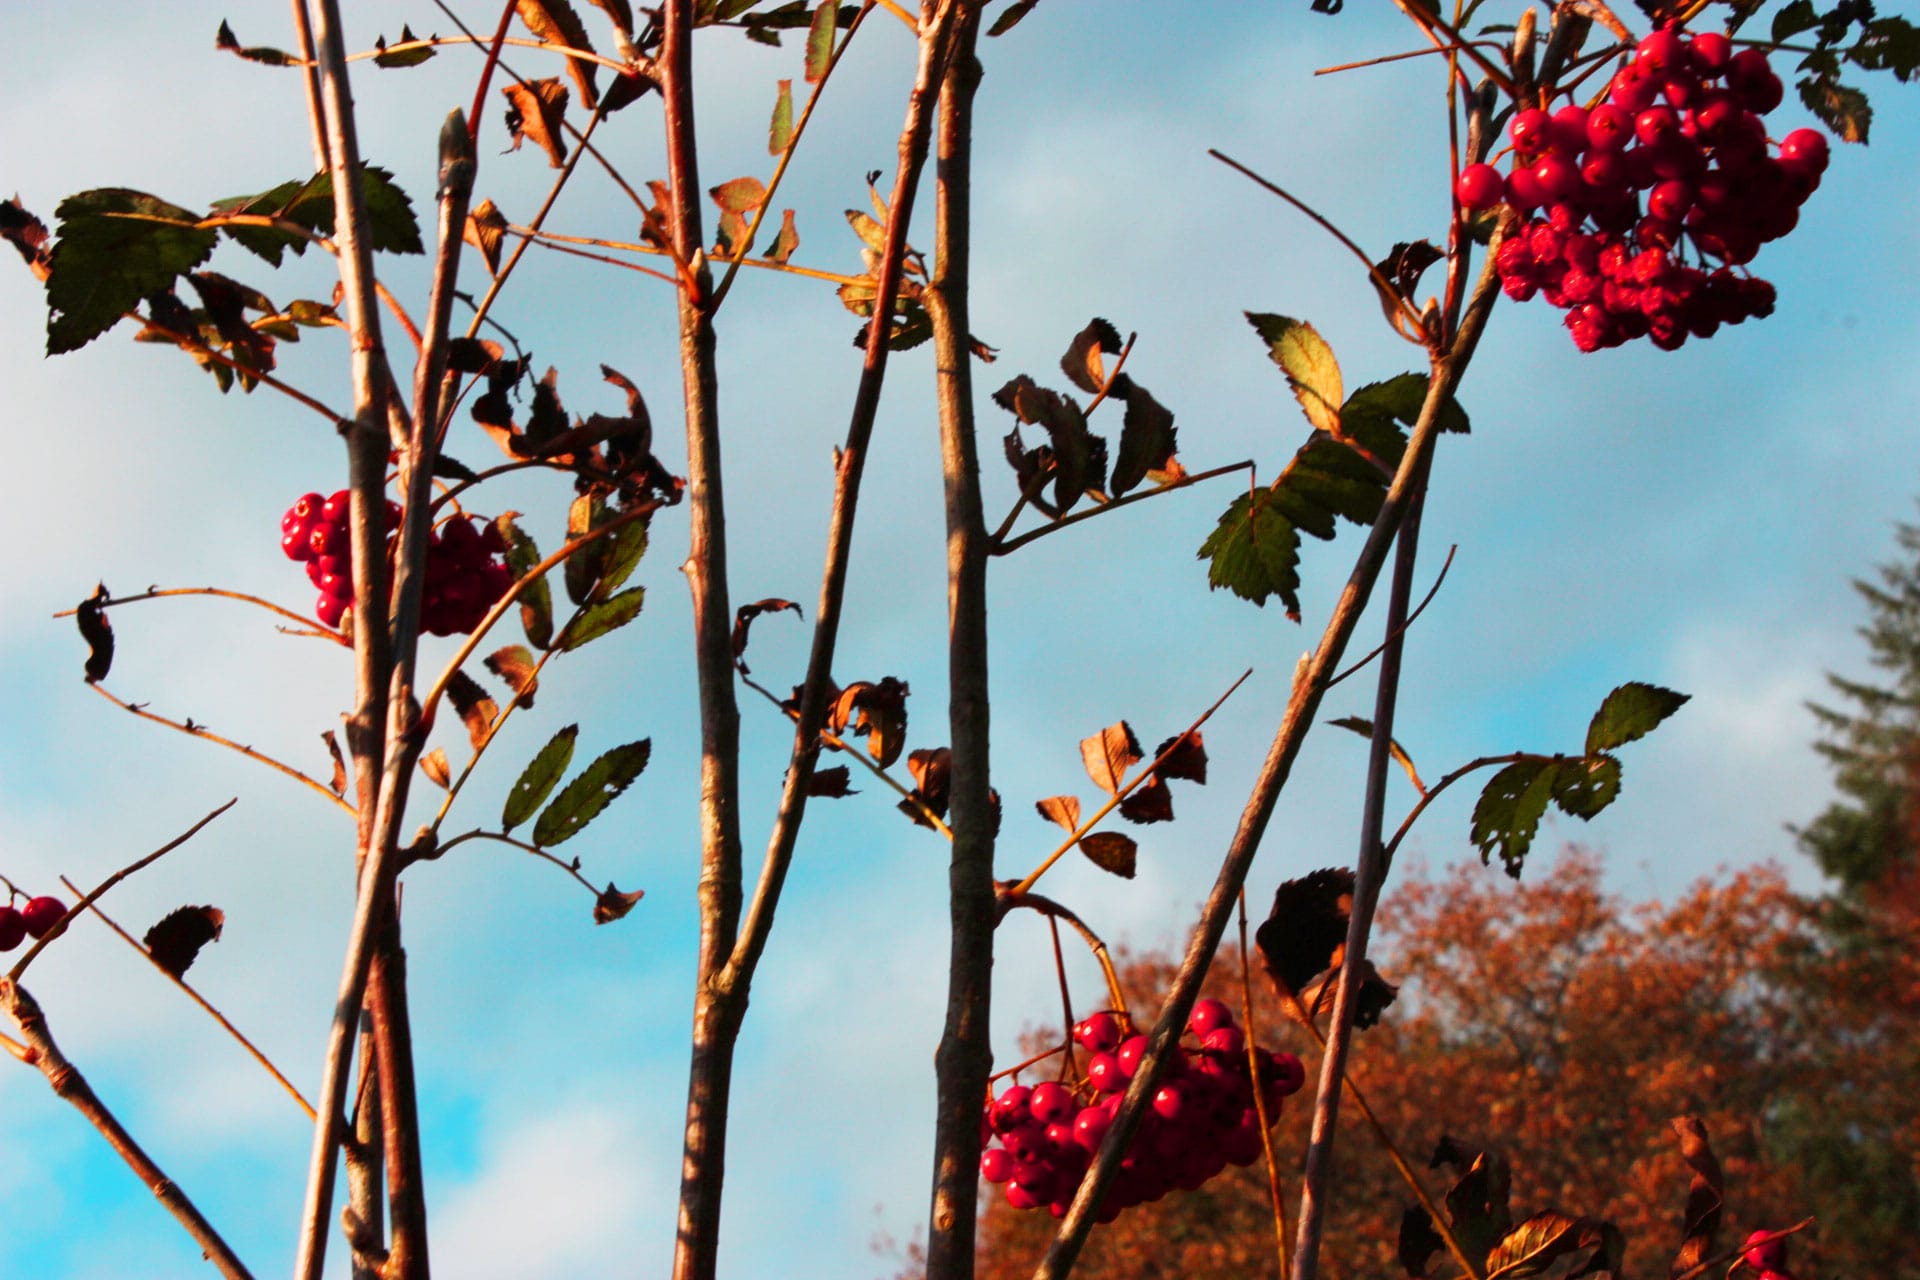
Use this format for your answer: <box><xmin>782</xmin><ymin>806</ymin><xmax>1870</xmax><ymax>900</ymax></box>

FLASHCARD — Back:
<box><xmin>0</xmin><ymin>0</ymin><xmax>1920</xmax><ymax>1280</ymax></box>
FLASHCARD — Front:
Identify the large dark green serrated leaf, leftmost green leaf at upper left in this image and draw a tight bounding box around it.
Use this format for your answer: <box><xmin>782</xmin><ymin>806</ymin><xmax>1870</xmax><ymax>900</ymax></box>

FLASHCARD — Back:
<box><xmin>46</xmin><ymin>186</ymin><xmax>219</xmax><ymax>355</ymax></box>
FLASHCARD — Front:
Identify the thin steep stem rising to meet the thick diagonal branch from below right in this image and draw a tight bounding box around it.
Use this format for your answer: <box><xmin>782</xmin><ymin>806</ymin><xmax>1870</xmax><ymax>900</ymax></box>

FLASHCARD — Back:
<box><xmin>1294</xmin><ymin>455</ymin><xmax>1436</xmax><ymax>1280</ymax></box>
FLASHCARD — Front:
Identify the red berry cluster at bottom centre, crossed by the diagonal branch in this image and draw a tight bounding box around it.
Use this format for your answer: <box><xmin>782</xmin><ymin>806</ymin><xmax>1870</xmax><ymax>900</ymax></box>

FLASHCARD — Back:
<box><xmin>979</xmin><ymin>1000</ymin><xmax>1306</xmax><ymax>1222</ymax></box>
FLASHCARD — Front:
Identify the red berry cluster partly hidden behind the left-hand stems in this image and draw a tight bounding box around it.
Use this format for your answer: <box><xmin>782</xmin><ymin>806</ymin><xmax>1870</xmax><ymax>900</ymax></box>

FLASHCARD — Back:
<box><xmin>280</xmin><ymin>489</ymin><xmax>513</xmax><ymax>635</ymax></box>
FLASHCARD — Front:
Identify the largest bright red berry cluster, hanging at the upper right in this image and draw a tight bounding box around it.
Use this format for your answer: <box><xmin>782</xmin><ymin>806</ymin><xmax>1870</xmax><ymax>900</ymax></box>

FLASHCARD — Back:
<box><xmin>1455</xmin><ymin>27</ymin><xmax>1828</xmax><ymax>351</ymax></box>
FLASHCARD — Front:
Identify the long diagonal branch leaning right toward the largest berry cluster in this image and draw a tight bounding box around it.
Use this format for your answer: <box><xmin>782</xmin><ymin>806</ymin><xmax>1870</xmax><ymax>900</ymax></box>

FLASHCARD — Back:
<box><xmin>1033</xmin><ymin>232</ymin><xmax>1500</xmax><ymax>1280</ymax></box>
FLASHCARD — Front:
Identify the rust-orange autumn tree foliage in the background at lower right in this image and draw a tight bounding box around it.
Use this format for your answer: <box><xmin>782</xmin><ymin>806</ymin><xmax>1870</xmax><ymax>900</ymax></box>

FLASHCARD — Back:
<box><xmin>944</xmin><ymin>850</ymin><xmax>1920</xmax><ymax>1280</ymax></box>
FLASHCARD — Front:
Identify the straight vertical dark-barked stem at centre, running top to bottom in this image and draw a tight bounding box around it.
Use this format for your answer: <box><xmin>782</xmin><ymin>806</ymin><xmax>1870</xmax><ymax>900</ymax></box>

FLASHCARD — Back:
<box><xmin>927</xmin><ymin>4</ymin><xmax>998</xmax><ymax>1280</ymax></box>
